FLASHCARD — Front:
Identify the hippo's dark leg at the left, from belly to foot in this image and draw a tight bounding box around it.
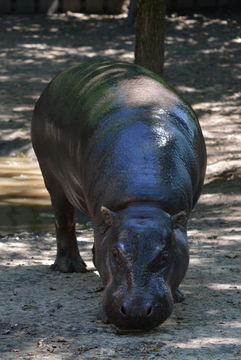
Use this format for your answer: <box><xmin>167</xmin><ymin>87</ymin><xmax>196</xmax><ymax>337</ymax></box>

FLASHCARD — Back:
<box><xmin>41</xmin><ymin>167</ymin><xmax>87</xmax><ymax>272</ymax></box>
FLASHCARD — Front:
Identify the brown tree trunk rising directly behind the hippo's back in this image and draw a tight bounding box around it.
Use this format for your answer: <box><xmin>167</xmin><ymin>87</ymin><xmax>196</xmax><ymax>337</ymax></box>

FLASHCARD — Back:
<box><xmin>135</xmin><ymin>0</ymin><xmax>166</xmax><ymax>75</ymax></box>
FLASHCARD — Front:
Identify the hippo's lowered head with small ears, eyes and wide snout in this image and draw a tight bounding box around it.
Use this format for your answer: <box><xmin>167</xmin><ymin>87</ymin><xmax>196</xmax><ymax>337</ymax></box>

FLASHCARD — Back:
<box><xmin>95</xmin><ymin>204</ymin><xmax>189</xmax><ymax>330</ymax></box>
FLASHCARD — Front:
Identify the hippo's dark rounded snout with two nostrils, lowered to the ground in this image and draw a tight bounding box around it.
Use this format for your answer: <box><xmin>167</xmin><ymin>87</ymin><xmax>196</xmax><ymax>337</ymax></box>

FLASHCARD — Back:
<box><xmin>104</xmin><ymin>288</ymin><xmax>173</xmax><ymax>330</ymax></box>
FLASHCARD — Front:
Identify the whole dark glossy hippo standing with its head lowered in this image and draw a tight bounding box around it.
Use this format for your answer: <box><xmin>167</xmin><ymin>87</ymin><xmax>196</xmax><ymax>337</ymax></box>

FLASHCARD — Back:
<box><xmin>32</xmin><ymin>60</ymin><xmax>206</xmax><ymax>330</ymax></box>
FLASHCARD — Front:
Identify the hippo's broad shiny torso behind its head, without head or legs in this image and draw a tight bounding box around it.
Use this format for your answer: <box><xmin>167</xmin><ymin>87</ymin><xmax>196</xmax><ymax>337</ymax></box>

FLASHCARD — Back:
<box><xmin>32</xmin><ymin>60</ymin><xmax>205</xmax><ymax>214</ymax></box>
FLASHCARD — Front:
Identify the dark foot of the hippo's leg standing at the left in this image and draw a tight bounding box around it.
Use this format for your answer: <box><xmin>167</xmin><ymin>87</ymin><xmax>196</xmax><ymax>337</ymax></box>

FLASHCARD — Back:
<box><xmin>50</xmin><ymin>256</ymin><xmax>88</xmax><ymax>272</ymax></box>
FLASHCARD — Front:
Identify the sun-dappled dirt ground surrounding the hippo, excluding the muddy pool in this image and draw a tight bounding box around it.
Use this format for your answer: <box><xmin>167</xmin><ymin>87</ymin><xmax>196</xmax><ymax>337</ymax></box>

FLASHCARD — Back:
<box><xmin>0</xmin><ymin>11</ymin><xmax>241</xmax><ymax>360</ymax></box>
